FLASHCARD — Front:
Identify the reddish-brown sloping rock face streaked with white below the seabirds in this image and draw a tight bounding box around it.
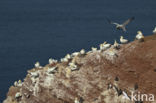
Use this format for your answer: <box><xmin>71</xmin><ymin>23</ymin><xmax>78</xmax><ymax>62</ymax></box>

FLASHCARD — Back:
<box><xmin>3</xmin><ymin>36</ymin><xmax>156</xmax><ymax>103</ymax></box>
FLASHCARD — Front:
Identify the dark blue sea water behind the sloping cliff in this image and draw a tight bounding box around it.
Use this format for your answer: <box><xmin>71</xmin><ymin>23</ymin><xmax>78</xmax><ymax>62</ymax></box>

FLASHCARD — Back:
<box><xmin>0</xmin><ymin>0</ymin><xmax>156</xmax><ymax>102</ymax></box>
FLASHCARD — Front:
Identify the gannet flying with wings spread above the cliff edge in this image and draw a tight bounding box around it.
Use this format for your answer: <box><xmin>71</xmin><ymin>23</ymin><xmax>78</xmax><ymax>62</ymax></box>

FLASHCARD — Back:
<box><xmin>107</xmin><ymin>17</ymin><xmax>134</xmax><ymax>32</ymax></box>
